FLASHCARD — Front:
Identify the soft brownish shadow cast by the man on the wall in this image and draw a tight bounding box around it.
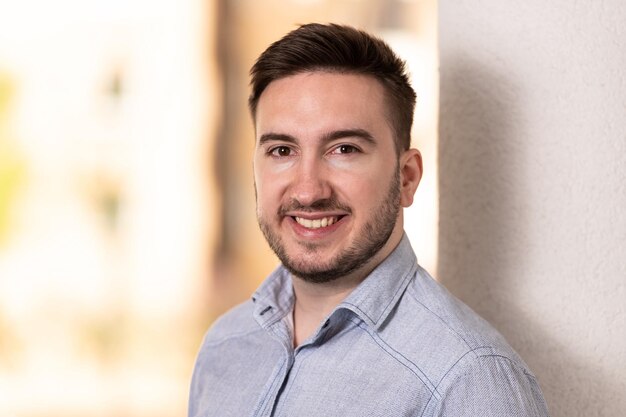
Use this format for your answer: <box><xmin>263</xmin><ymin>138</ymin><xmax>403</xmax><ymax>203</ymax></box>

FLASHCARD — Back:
<box><xmin>438</xmin><ymin>57</ymin><xmax>616</xmax><ymax>417</ymax></box>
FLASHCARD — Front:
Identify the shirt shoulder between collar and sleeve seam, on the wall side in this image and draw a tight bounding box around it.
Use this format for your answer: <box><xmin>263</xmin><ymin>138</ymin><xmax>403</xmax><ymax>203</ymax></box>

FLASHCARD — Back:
<box><xmin>381</xmin><ymin>268</ymin><xmax>530</xmax><ymax>386</ymax></box>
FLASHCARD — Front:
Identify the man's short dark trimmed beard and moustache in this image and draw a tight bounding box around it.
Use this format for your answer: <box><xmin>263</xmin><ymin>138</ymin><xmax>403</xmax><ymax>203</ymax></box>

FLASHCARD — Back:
<box><xmin>257</xmin><ymin>168</ymin><xmax>400</xmax><ymax>284</ymax></box>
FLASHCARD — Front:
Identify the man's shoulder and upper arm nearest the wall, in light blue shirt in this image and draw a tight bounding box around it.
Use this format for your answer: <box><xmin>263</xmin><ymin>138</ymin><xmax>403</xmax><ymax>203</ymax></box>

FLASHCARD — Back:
<box><xmin>382</xmin><ymin>268</ymin><xmax>548</xmax><ymax>417</ymax></box>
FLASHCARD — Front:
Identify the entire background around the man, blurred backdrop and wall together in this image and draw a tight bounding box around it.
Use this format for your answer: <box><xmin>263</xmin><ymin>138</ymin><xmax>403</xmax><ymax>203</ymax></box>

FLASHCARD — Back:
<box><xmin>0</xmin><ymin>0</ymin><xmax>626</xmax><ymax>417</ymax></box>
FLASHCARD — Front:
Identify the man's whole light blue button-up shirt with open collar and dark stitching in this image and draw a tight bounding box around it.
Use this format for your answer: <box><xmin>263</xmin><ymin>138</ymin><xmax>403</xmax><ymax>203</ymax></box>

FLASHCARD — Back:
<box><xmin>189</xmin><ymin>236</ymin><xmax>548</xmax><ymax>417</ymax></box>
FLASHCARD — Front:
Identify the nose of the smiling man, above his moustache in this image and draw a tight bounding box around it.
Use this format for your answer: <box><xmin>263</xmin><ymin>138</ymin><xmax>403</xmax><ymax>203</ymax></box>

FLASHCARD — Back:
<box><xmin>291</xmin><ymin>157</ymin><xmax>332</xmax><ymax>206</ymax></box>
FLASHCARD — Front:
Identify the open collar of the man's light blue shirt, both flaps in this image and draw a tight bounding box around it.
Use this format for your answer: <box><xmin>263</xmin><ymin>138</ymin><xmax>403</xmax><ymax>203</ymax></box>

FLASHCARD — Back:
<box><xmin>252</xmin><ymin>234</ymin><xmax>417</xmax><ymax>329</ymax></box>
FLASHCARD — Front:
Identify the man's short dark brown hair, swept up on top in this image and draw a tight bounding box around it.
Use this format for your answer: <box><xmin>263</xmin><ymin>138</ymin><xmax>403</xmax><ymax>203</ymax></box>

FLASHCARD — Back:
<box><xmin>248</xmin><ymin>23</ymin><xmax>416</xmax><ymax>154</ymax></box>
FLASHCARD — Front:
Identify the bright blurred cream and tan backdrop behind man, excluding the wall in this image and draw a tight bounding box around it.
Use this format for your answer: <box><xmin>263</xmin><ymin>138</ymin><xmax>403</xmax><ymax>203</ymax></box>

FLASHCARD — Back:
<box><xmin>0</xmin><ymin>0</ymin><xmax>438</xmax><ymax>417</ymax></box>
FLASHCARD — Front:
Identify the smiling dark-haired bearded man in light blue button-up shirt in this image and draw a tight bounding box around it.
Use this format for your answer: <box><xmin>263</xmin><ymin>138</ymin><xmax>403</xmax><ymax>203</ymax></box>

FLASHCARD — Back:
<box><xmin>189</xmin><ymin>24</ymin><xmax>548</xmax><ymax>417</ymax></box>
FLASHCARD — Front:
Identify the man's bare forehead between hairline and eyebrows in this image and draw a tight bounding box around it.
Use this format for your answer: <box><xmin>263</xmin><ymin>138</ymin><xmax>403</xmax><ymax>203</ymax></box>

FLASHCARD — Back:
<box><xmin>255</xmin><ymin>71</ymin><xmax>389</xmax><ymax>136</ymax></box>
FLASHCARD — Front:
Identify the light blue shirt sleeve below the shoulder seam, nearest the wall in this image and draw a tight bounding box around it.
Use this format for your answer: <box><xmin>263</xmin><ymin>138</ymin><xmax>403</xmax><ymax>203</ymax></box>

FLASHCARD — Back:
<box><xmin>434</xmin><ymin>356</ymin><xmax>549</xmax><ymax>417</ymax></box>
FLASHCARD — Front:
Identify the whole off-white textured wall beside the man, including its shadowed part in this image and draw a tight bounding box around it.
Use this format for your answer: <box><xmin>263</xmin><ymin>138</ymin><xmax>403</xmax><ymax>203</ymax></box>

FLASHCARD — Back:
<box><xmin>438</xmin><ymin>0</ymin><xmax>626</xmax><ymax>417</ymax></box>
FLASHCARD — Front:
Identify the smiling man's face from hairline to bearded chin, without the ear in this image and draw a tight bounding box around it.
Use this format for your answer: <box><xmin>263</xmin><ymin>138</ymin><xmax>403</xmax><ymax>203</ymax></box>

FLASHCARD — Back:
<box><xmin>254</xmin><ymin>72</ymin><xmax>414</xmax><ymax>282</ymax></box>
